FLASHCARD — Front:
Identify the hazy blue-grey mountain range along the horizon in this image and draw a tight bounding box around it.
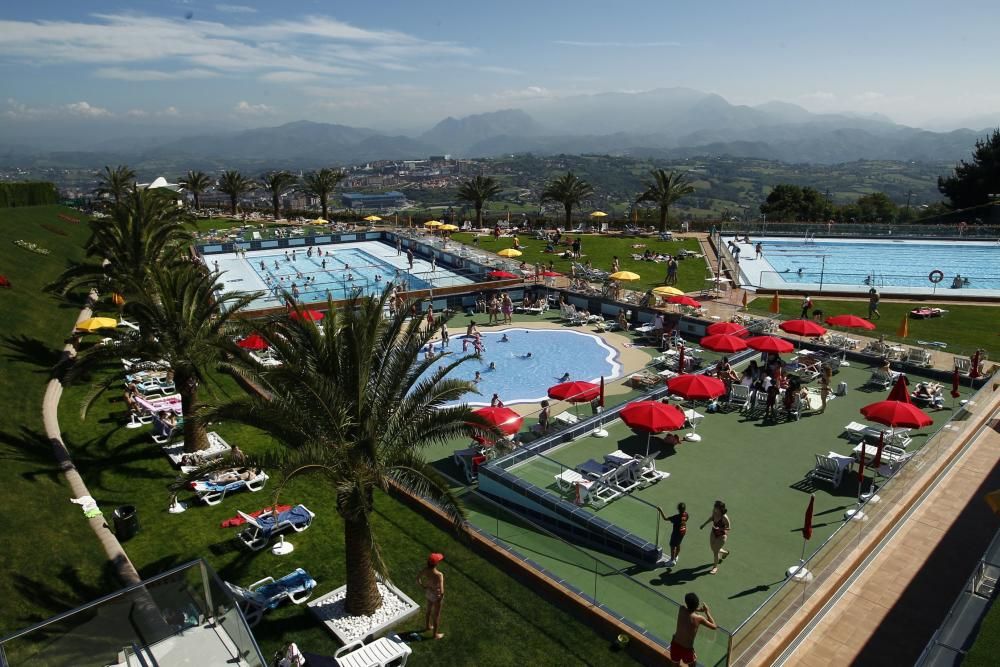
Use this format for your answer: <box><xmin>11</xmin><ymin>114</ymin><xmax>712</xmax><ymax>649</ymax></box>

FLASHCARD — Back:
<box><xmin>0</xmin><ymin>88</ymin><xmax>984</xmax><ymax>170</ymax></box>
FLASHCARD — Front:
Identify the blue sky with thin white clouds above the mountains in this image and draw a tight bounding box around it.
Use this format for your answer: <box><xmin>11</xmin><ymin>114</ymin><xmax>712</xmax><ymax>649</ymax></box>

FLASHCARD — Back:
<box><xmin>0</xmin><ymin>0</ymin><xmax>1000</xmax><ymax>129</ymax></box>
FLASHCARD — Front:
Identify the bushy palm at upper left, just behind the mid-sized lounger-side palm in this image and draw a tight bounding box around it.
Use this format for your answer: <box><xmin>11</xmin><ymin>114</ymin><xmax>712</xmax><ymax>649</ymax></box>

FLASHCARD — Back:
<box><xmin>48</xmin><ymin>186</ymin><xmax>192</xmax><ymax>298</ymax></box>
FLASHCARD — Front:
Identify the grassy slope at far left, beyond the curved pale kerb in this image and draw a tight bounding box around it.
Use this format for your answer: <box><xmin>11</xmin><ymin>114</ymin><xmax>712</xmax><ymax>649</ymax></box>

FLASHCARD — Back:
<box><xmin>0</xmin><ymin>206</ymin><xmax>112</xmax><ymax>635</ymax></box>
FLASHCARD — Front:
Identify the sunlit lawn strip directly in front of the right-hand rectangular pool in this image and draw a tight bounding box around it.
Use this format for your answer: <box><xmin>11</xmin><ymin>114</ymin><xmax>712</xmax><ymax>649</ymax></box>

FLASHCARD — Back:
<box><xmin>749</xmin><ymin>295</ymin><xmax>1000</xmax><ymax>359</ymax></box>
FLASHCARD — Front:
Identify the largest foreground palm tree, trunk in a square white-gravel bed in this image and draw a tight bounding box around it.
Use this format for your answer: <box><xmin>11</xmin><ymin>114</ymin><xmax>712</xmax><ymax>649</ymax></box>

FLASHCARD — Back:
<box><xmin>199</xmin><ymin>291</ymin><xmax>499</xmax><ymax>615</ymax></box>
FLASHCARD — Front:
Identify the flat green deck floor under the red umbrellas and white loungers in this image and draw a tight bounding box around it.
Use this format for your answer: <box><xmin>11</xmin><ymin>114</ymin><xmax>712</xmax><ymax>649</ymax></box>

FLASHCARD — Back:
<box><xmin>488</xmin><ymin>366</ymin><xmax>971</xmax><ymax>638</ymax></box>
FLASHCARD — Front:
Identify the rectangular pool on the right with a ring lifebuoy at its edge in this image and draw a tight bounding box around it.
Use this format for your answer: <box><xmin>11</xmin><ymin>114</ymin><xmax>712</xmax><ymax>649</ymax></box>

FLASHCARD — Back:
<box><xmin>736</xmin><ymin>237</ymin><xmax>1000</xmax><ymax>295</ymax></box>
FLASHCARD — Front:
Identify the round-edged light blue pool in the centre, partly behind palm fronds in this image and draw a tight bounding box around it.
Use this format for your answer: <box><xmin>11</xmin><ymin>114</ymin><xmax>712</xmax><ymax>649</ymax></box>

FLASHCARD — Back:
<box><xmin>418</xmin><ymin>328</ymin><xmax>621</xmax><ymax>405</ymax></box>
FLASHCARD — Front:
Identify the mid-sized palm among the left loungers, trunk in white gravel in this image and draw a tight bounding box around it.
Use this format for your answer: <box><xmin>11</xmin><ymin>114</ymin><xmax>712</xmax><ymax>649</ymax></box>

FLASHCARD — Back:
<box><xmin>74</xmin><ymin>263</ymin><xmax>261</xmax><ymax>452</ymax></box>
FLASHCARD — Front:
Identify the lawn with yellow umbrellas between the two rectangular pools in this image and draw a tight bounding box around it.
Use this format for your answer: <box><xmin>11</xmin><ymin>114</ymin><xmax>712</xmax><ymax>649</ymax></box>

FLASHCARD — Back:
<box><xmin>452</xmin><ymin>232</ymin><xmax>707</xmax><ymax>292</ymax></box>
